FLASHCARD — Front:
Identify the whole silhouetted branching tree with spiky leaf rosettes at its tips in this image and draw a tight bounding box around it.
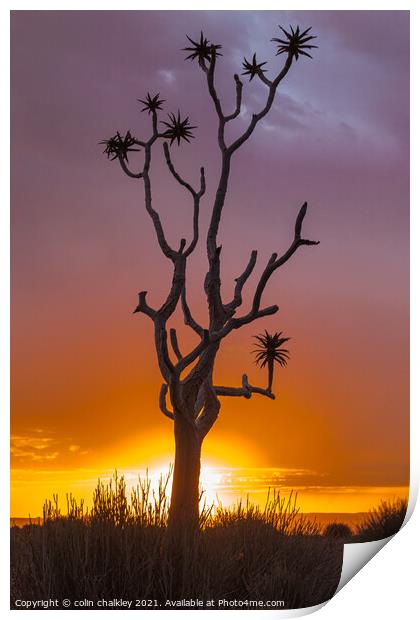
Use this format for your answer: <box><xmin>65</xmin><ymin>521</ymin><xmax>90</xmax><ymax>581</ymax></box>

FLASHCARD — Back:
<box><xmin>101</xmin><ymin>27</ymin><xmax>318</xmax><ymax>530</ymax></box>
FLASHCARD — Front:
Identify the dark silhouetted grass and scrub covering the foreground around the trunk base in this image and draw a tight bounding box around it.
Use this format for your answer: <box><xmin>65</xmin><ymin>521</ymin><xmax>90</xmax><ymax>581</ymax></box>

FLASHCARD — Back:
<box><xmin>11</xmin><ymin>474</ymin><xmax>408</xmax><ymax>609</ymax></box>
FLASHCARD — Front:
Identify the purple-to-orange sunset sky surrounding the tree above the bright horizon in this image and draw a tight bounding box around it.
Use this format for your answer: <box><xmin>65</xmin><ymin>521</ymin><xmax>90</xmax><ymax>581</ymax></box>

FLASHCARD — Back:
<box><xmin>11</xmin><ymin>11</ymin><xmax>409</xmax><ymax>516</ymax></box>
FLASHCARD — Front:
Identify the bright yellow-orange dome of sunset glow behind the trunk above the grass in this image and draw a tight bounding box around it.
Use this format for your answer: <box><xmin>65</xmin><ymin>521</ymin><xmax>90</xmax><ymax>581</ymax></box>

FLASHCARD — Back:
<box><xmin>11</xmin><ymin>427</ymin><xmax>408</xmax><ymax>517</ymax></box>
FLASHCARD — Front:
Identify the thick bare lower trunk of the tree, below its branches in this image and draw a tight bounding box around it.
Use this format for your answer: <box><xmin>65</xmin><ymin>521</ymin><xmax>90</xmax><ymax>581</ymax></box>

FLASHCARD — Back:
<box><xmin>169</xmin><ymin>413</ymin><xmax>202</xmax><ymax>533</ymax></box>
